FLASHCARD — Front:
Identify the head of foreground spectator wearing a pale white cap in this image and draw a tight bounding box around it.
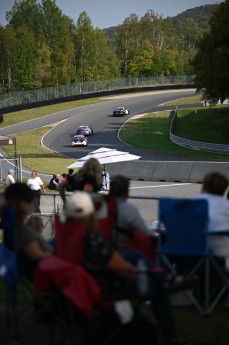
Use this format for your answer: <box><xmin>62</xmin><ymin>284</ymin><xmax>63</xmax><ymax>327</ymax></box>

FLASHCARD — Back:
<box><xmin>64</xmin><ymin>191</ymin><xmax>97</xmax><ymax>231</ymax></box>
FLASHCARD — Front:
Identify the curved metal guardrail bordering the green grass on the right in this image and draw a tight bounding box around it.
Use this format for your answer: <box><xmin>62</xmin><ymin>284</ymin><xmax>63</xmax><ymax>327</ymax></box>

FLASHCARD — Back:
<box><xmin>169</xmin><ymin>107</ymin><xmax>229</xmax><ymax>155</ymax></box>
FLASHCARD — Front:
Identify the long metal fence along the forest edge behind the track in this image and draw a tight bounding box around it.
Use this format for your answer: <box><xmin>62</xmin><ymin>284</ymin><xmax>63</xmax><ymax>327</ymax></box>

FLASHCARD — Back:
<box><xmin>0</xmin><ymin>76</ymin><xmax>193</xmax><ymax>108</ymax></box>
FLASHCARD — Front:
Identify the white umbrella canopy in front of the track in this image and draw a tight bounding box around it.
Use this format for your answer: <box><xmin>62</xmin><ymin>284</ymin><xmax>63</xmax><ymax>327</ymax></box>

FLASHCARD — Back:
<box><xmin>68</xmin><ymin>147</ymin><xmax>141</xmax><ymax>168</ymax></box>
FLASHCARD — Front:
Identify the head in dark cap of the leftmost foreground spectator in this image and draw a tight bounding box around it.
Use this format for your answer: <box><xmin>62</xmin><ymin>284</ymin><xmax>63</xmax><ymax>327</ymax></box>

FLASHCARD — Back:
<box><xmin>4</xmin><ymin>182</ymin><xmax>35</xmax><ymax>218</ymax></box>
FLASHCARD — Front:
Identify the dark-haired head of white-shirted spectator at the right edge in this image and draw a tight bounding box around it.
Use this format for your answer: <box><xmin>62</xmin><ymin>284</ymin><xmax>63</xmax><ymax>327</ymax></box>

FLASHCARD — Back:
<box><xmin>202</xmin><ymin>172</ymin><xmax>229</xmax><ymax>196</ymax></box>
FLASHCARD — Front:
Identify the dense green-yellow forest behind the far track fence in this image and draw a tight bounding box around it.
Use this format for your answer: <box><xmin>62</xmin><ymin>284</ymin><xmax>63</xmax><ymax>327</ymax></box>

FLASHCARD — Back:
<box><xmin>0</xmin><ymin>0</ymin><xmax>214</xmax><ymax>94</ymax></box>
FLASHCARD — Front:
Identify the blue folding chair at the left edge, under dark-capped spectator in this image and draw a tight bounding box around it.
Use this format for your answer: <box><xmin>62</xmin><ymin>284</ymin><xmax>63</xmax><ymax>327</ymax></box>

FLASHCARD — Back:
<box><xmin>0</xmin><ymin>208</ymin><xmax>84</xmax><ymax>344</ymax></box>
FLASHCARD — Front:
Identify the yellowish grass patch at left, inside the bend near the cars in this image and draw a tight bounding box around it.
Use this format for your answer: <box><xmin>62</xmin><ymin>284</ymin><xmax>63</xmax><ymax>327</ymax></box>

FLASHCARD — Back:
<box><xmin>3</xmin><ymin>127</ymin><xmax>75</xmax><ymax>174</ymax></box>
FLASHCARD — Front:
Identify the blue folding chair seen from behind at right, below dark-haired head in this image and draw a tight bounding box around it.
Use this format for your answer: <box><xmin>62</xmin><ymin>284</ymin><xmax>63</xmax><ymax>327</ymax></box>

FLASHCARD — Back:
<box><xmin>158</xmin><ymin>198</ymin><xmax>229</xmax><ymax>315</ymax></box>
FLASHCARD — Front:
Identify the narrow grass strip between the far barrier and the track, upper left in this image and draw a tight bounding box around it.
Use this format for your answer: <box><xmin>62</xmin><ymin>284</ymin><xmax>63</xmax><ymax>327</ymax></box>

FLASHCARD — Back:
<box><xmin>0</xmin><ymin>98</ymin><xmax>106</xmax><ymax>128</ymax></box>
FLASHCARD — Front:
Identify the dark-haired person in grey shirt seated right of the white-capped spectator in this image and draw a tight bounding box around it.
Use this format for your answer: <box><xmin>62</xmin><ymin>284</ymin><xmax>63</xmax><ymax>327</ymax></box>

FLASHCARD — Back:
<box><xmin>110</xmin><ymin>175</ymin><xmax>152</xmax><ymax>252</ymax></box>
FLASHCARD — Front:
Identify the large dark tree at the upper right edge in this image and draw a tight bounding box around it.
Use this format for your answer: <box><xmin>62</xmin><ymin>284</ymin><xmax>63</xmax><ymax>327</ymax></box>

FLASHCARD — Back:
<box><xmin>192</xmin><ymin>0</ymin><xmax>229</xmax><ymax>104</ymax></box>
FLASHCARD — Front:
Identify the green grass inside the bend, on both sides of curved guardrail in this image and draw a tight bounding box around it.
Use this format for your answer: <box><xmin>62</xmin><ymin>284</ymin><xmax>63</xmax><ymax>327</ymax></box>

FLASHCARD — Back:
<box><xmin>120</xmin><ymin>108</ymin><xmax>229</xmax><ymax>160</ymax></box>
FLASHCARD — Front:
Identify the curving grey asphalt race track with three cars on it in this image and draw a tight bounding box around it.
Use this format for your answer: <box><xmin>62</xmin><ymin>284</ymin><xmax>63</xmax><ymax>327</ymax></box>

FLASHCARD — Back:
<box><xmin>40</xmin><ymin>90</ymin><xmax>197</xmax><ymax>160</ymax></box>
